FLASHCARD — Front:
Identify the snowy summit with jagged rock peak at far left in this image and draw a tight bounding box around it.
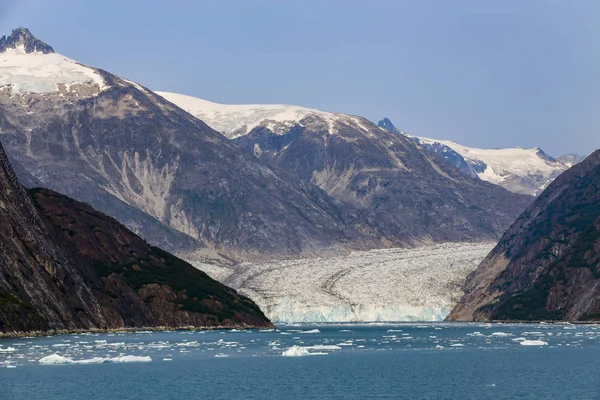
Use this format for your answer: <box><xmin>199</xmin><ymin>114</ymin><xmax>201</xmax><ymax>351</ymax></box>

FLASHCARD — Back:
<box><xmin>0</xmin><ymin>28</ymin><xmax>106</xmax><ymax>95</ymax></box>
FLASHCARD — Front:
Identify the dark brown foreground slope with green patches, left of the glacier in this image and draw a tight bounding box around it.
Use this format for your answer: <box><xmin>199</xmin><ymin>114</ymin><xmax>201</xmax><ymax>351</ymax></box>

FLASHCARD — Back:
<box><xmin>0</xmin><ymin>139</ymin><xmax>271</xmax><ymax>334</ymax></box>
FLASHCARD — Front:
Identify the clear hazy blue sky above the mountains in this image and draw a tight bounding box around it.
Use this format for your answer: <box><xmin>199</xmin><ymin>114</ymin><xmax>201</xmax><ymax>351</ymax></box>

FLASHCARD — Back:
<box><xmin>0</xmin><ymin>0</ymin><xmax>600</xmax><ymax>156</ymax></box>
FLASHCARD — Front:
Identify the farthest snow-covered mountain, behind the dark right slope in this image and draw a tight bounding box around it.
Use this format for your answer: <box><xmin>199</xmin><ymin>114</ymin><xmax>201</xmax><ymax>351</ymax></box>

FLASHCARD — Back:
<box><xmin>378</xmin><ymin>118</ymin><xmax>583</xmax><ymax>196</ymax></box>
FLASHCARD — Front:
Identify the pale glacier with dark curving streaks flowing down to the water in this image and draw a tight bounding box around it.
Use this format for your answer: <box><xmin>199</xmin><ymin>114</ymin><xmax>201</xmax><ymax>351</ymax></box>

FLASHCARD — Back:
<box><xmin>191</xmin><ymin>243</ymin><xmax>495</xmax><ymax>323</ymax></box>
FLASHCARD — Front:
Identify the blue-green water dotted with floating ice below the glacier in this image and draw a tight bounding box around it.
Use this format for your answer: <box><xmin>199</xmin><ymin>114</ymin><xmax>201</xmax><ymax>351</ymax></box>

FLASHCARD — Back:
<box><xmin>0</xmin><ymin>324</ymin><xmax>600</xmax><ymax>400</ymax></box>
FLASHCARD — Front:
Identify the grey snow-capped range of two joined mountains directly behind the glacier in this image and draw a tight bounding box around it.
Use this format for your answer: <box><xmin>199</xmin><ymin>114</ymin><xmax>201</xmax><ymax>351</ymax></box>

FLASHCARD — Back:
<box><xmin>0</xmin><ymin>29</ymin><xmax>531</xmax><ymax>262</ymax></box>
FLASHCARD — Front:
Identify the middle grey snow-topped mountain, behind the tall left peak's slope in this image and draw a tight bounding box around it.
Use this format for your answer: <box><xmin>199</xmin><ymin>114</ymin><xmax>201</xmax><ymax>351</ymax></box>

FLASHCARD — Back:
<box><xmin>157</xmin><ymin>92</ymin><xmax>530</xmax><ymax>246</ymax></box>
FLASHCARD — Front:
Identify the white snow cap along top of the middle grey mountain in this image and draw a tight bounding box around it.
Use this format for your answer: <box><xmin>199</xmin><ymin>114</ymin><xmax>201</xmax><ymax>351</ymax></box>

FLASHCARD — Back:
<box><xmin>156</xmin><ymin>92</ymin><xmax>366</xmax><ymax>139</ymax></box>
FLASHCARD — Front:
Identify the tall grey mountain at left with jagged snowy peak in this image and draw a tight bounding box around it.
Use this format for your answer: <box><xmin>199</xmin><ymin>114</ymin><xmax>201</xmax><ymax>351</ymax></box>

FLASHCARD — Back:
<box><xmin>0</xmin><ymin>29</ymin><xmax>369</xmax><ymax>261</ymax></box>
